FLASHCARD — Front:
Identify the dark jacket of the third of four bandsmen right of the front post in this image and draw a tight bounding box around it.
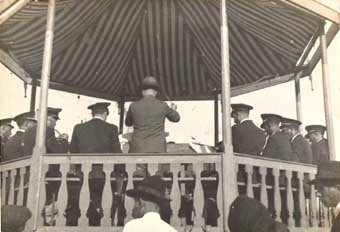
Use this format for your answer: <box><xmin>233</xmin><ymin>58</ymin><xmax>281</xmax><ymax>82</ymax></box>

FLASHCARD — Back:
<box><xmin>291</xmin><ymin>135</ymin><xmax>313</xmax><ymax>164</ymax></box>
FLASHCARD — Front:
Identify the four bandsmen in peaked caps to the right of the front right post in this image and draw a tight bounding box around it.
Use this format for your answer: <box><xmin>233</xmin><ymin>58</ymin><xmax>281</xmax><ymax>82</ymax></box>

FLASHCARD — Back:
<box><xmin>217</xmin><ymin>104</ymin><xmax>329</xmax><ymax>164</ymax></box>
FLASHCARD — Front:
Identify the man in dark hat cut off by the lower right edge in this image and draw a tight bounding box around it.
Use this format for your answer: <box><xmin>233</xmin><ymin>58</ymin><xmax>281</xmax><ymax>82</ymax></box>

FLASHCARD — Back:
<box><xmin>311</xmin><ymin>161</ymin><xmax>340</xmax><ymax>232</ymax></box>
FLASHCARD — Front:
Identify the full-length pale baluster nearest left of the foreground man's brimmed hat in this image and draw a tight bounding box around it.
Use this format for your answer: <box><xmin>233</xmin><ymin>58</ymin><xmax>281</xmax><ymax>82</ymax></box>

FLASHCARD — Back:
<box><xmin>101</xmin><ymin>164</ymin><xmax>113</xmax><ymax>226</ymax></box>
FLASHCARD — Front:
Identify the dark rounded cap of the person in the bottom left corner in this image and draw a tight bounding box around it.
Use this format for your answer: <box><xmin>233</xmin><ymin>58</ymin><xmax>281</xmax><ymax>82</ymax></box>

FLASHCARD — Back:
<box><xmin>1</xmin><ymin>205</ymin><xmax>32</xmax><ymax>232</ymax></box>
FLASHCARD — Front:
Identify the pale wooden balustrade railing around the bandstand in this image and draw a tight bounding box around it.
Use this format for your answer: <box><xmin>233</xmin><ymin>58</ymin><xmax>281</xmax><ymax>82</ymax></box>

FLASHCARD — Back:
<box><xmin>1</xmin><ymin>153</ymin><xmax>330</xmax><ymax>231</ymax></box>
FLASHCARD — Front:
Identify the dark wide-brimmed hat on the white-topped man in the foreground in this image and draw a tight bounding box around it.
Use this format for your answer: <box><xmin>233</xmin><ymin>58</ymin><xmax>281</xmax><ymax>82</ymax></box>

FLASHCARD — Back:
<box><xmin>126</xmin><ymin>175</ymin><xmax>169</xmax><ymax>203</ymax></box>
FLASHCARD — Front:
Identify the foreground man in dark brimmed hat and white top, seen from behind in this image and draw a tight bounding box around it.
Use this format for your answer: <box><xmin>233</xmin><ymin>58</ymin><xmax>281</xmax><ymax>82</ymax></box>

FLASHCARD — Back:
<box><xmin>123</xmin><ymin>175</ymin><xmax>176</xmax><ymax>232</ymax></box>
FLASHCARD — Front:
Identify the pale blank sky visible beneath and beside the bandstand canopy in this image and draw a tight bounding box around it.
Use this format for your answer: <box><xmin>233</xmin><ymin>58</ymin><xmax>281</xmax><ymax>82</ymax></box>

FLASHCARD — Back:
<box><xmin>0</xmin><ymin>0</ymin><xmax>340</xmax><ymax>160</ymax></box>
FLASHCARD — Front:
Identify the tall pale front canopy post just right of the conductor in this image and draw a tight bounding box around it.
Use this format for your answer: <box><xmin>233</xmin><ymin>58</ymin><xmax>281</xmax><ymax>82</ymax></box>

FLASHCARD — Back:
<box><xmin>221</xmin><ymin>0</ymin><xmax>237</xmax><ymax>232</ymax></box>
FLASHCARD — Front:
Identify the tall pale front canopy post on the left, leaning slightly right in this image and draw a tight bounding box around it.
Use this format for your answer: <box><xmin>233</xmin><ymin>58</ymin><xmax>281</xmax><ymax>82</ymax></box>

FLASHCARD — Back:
<box><xmin>28</xmin><ymin>0</ymin><xmax>55</xmax><ymax>231</ymax></box>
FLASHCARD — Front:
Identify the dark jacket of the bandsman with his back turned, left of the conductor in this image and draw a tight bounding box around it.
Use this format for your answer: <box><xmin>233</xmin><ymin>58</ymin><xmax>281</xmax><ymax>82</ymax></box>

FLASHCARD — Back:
<box><xmin>70</xmin><ymin>118</ymin><xmax>122</xmax><ymax>153</ymax></box>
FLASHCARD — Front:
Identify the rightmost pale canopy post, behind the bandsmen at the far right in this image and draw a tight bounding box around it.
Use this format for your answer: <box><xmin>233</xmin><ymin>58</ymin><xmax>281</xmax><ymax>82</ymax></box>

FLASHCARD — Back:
<box><xmin>320</xmin><ymin>26</ymin><xmax>336</xmax><ymax>160</ymax></box>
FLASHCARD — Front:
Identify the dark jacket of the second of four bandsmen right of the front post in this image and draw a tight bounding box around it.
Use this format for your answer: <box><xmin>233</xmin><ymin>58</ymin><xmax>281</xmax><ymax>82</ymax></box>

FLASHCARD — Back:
<box><xmin>262</xmin><ymin>131</ymin><xmax>297</xmax><ymax>161</ymax></box>
